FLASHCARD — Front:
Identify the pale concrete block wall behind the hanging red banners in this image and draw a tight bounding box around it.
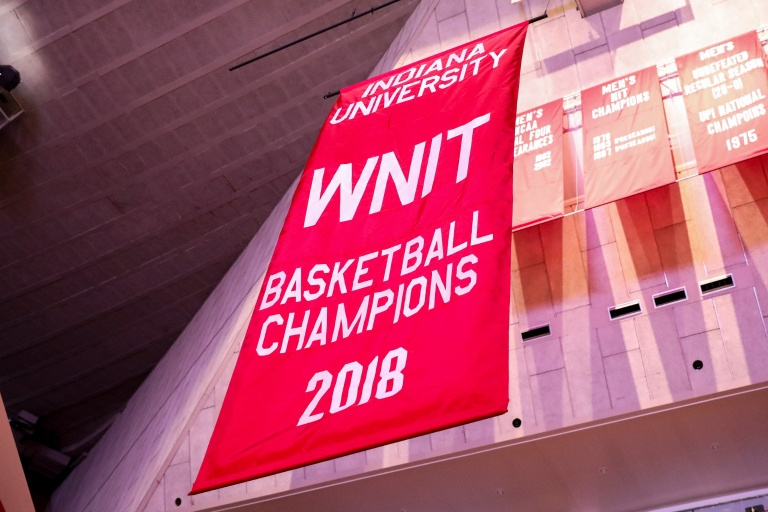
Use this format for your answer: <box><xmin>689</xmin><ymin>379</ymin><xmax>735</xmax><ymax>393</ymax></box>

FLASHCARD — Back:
<box><xmin>51</xmin><ymin>0</ymin><xmax>768</xmax><ymax>512</ymax></box>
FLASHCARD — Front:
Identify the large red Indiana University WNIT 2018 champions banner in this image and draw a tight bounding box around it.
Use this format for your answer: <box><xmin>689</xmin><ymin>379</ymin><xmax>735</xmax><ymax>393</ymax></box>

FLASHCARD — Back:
<box><xmin>192</xmin><ymin>23</ymin><xmax>528</xmax><ymax>494</ymax></box>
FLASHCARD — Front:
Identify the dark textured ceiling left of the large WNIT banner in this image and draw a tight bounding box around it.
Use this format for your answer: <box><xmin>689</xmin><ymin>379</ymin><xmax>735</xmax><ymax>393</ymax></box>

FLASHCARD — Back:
<box><xmin>0</xmin><ymin>0</ymin><xmax>418</xmax><ymax>453</ymax></box>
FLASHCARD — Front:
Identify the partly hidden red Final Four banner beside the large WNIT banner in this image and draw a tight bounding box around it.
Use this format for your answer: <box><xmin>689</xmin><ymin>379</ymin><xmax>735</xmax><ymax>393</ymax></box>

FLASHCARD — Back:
<box><xmin>512</xmin><ymin>99</ymin><xmax>564</xmax><ymax>229</ymax></box>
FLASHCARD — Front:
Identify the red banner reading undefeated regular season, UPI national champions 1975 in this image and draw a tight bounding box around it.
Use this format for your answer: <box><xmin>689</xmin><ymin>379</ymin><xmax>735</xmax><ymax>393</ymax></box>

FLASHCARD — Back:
<box><xmin>676</xmin><ymin>31</ymin><xmax>768</xmax><ymax>173</ymax></box>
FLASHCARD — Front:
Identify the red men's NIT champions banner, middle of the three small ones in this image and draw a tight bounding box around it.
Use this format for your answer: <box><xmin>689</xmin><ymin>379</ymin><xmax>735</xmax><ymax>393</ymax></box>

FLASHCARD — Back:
<box><xmin>581</xmin><ymin>66</ymin><xmax>675</xmax><ymax>208</ymax></box>
